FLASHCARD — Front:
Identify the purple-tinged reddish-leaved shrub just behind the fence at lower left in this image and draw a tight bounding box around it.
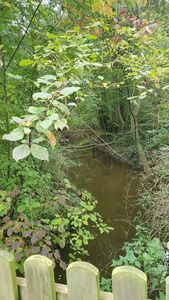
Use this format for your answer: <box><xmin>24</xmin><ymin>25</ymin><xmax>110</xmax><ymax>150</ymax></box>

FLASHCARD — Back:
<box><xmin>0</xmin><ymin>216</ymin><xmax>66</xmax><ymax>272</ymax></box>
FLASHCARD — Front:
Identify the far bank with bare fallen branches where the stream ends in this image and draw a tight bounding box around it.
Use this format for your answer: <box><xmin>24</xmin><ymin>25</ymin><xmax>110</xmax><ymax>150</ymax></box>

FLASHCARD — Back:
<box><xmin>63</xmin><ymin>128</ymin><xmax>143</xmax><ymax>171</ymax></box>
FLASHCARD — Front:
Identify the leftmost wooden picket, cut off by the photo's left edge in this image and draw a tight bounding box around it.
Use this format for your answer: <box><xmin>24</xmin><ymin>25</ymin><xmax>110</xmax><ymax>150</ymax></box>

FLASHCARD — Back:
<box><xmin>0</xmin><ymin>250</ymin><xmax>19</xmax><ymax>300</ymax></box>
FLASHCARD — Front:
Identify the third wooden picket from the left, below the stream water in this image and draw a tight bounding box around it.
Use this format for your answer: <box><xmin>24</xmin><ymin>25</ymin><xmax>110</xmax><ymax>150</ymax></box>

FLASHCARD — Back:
<box><xmin>66</xmin><ymin>262</ymin><xmax>100</xmax><ymax>300</ymax></box>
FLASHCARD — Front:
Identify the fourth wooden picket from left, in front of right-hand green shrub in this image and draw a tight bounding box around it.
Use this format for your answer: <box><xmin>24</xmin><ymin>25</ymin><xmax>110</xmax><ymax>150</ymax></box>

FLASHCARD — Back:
<box><xmin>112</xmin><ymin>266</ymin><xmax>147</xmax><ymax>300</ymax></box>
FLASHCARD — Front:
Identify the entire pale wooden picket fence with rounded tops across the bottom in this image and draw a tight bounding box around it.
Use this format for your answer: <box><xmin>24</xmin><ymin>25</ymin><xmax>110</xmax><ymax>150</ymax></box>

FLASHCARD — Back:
<box><xmin>0</xmin><ymin>251</ymin><xmax>169</xmax><ymax>300</ymax></box>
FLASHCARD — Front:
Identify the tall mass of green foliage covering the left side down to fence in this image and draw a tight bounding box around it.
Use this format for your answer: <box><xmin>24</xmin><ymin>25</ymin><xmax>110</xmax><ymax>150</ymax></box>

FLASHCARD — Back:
<box><xmin>0</xmin><ymin>1</ymin><xmax>111</xmax><ymax>271</ymax></box>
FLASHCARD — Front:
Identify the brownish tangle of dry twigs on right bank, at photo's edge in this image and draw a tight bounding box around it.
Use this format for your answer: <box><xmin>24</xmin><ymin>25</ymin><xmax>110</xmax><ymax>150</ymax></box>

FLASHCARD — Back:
<box><xmin>139</xmin><ymin>147</ymin><xmax>169</xmax><ymax>242</ymax></box>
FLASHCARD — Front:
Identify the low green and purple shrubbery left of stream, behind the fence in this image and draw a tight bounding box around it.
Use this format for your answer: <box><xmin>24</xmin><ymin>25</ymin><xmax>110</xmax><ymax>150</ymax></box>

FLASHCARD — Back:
<box><xmin>0</xmin><ymin>169</ymin><xmax>111</xmax><ymax>271</ymax></box>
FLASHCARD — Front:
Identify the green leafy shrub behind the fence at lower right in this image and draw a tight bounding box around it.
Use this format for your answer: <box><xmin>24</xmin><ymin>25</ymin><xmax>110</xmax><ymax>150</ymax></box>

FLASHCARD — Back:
<box><xmin>112</xmin><ymin>225</ymin><xmax>168</xmax><ymax>299</ymax></box>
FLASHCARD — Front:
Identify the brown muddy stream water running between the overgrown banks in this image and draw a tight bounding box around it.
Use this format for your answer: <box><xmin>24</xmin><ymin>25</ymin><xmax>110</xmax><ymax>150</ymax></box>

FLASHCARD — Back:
<box><xmin>68</xmin><ymin>153</ymin><xmax>139</xmax><ymax>276</ymax></box>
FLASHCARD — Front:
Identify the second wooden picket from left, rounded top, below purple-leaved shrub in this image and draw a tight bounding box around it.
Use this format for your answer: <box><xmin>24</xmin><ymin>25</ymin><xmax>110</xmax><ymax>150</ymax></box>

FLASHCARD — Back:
<box><xmin>24</xmin><ymin>255</ymin><xmax>56</xmax><ymax>300</ymax></box>
